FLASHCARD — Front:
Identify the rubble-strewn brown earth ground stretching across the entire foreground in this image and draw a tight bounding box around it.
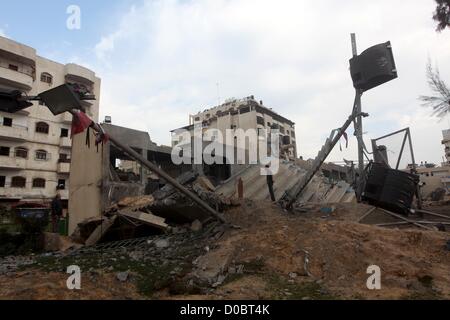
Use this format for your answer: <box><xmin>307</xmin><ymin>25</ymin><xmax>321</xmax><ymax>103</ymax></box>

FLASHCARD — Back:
<box><xmin>0</xmin><ymin>201</ymin><xmax>450</xmax><ymax>300</ymax></box>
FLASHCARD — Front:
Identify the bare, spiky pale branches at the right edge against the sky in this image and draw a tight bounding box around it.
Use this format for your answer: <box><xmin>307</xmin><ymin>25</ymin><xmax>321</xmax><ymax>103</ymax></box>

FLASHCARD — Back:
<box><xmin>419</xmin><ymin>61</ymin><xmax>450</xmax><ymax>121</ymax></box>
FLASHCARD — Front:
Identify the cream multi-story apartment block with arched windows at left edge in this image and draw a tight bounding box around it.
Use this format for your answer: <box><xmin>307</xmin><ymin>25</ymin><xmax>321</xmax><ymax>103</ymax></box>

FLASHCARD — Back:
<box><xmin>0</xmin><ymin>37</ymin><xmax>100</xmax><ymax>203</ymax></box>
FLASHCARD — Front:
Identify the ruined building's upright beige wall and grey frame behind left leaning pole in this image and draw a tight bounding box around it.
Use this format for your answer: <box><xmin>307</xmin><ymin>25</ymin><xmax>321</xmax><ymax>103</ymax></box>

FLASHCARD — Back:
<box><xmin>69</xmin><ymin>123</ymin><xmax>191</xmax><ymax>234</ymax></box>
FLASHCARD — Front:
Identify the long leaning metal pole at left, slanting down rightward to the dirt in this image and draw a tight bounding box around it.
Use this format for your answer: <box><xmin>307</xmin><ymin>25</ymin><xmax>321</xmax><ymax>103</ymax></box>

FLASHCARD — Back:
<box><xmin>71</xmin><ymin>112</ymin><xmax>226</xmax><ymax>223</ymax></box>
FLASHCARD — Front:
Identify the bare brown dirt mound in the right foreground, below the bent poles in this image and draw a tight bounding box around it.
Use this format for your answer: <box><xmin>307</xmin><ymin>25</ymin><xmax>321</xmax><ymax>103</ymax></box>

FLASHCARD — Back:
<box><xmin>185</xmin><ymin>202</ymin><xmax>450</xmax><ymax>298</ymax></box>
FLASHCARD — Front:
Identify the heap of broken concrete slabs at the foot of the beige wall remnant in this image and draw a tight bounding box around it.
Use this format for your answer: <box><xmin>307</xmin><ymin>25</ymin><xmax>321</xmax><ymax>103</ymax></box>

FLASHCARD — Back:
<box><xmin>74</xmin><ymin>172</ymin><xmax>239</xmax><ymax>246</ymax></box>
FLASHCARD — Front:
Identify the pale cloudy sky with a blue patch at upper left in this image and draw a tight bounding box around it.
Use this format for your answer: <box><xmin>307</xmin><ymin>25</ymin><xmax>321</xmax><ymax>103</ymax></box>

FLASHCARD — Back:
<box><xmin>0</xmin><ymin>0</ymin><xmax>450</xmax><ymax>165</ymax></box>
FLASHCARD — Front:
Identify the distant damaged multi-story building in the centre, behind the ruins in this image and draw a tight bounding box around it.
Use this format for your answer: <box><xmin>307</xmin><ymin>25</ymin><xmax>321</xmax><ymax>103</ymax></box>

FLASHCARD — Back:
<box><xmin>172</xmin><ymin>96</ymin><xmax>297</xmax><ymax>159</ymax></box>
